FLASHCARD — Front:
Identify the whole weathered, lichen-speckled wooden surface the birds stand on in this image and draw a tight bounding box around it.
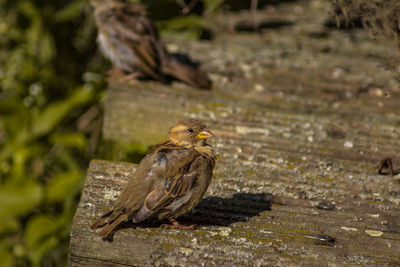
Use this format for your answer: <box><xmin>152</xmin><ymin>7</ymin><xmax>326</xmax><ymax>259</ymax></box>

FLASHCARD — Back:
<box><xmin>70</xmin><ymin>1</ymin><xmax>400</xmax><ymax>266</ymax></box>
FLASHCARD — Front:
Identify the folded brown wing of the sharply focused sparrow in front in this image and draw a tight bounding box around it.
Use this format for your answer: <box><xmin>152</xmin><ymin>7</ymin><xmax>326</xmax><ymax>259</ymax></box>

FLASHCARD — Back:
<box><xmin>131</xmin><ymin>149</ymin><xmax>200</xmax><ymax>222</ymax></box>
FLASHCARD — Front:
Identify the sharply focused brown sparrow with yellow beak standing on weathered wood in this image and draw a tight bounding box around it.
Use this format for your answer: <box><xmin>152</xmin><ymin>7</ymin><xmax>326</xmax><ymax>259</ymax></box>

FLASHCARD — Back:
<box><xmin>91</xmin><ymin>120</ymin><xmax>215</xmax><ymax>238</ymax></box>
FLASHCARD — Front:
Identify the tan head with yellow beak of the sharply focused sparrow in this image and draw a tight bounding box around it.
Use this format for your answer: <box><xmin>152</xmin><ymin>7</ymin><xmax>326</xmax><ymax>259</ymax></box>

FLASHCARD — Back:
<box><xmin>169</xmin><ymin>119</ymin><xmax>213</xmax><ymax>147</ymax></box>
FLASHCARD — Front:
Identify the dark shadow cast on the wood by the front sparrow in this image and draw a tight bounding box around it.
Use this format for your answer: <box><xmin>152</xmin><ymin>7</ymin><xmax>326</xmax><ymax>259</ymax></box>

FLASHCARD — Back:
<box><xmin>106</xmin><ymin>193</ymin><xmax>273</xmax><ymax>242</ymax></box>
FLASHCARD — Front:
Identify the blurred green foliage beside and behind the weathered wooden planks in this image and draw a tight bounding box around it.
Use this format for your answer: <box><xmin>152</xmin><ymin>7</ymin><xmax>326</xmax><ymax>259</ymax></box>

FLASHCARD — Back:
<box><xmin>0</xmin><ymin>0</ymin><xmax>223</xmax><ymax>266</ymax></box>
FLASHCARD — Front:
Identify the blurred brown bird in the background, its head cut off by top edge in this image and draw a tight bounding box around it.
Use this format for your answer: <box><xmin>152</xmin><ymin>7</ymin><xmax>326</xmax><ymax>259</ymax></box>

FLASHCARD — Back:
<box><xmin>90</xmin><ymin>0</ymin><xmax>211</xmax><ymax>89</ymax></box>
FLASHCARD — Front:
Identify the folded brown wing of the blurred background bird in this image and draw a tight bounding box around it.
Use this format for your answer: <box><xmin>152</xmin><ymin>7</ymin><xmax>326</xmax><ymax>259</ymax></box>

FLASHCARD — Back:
<box><xmin>110</xmin><ymin>4</ymin><xmax>164</xmax><ymax>79</ymax></box>
